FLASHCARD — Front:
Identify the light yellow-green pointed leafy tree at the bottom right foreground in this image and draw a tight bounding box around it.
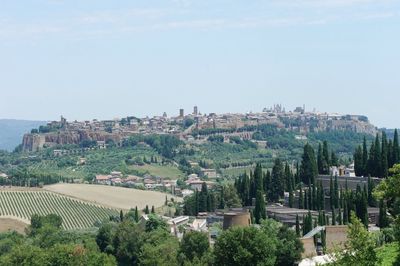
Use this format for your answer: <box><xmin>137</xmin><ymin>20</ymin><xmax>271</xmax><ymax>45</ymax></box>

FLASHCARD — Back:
<box><xmin>334</xmin><ymin>213</ymin><xmax>379</xmax><ymax>266</ymax></box>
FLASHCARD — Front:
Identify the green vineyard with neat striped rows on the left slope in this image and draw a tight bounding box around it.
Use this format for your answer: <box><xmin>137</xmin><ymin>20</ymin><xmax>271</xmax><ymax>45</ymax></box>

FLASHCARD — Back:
<box><xmin>0</xmin><ymin>191</ymin><xmax>118</xmax><ymax>229</ymax></box>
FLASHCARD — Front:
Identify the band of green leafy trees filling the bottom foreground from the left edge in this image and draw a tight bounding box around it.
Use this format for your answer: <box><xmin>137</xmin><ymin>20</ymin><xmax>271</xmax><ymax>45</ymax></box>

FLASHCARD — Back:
<box><xmin>0</xmin><ymin>214</ymin><xmax>303</xmax><ymax>266</ymax></box>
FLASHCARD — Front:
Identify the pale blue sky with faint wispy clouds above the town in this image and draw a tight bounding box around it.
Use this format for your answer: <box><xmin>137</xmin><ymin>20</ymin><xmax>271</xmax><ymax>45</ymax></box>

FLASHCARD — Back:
<box><xmin>0</xmin><ymin>0</ymin><xmax>400</xmax><ymax>128</ymax></box>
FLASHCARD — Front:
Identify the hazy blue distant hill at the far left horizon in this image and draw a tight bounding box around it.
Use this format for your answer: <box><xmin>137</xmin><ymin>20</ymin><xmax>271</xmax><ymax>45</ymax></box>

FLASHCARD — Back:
<box><xmin>0</xmin><ymin>119</ymin><xmax>47</xmax><ymax>151</ymax></box>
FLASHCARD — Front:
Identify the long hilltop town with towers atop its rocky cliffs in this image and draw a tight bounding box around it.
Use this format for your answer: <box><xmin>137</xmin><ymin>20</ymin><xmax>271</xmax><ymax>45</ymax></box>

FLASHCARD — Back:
<box><xmin>22</xmin><ymin>105</ymin><xmax>377</xmax><ymax>151</ymax></box>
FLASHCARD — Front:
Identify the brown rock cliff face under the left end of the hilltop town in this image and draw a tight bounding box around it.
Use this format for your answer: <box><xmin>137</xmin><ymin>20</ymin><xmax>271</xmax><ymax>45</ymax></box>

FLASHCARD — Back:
<box><xmin>22</xmin><ymin>130</ymin><xmax>125</xmax><ymax>151</ymax></box>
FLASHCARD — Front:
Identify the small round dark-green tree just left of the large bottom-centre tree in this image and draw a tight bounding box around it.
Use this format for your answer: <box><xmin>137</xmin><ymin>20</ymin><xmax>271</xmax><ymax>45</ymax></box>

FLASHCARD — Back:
<box><xmin>179</xmin><ymin>231</ymin><xmax>210</xmax><ymax>262</ymax></box>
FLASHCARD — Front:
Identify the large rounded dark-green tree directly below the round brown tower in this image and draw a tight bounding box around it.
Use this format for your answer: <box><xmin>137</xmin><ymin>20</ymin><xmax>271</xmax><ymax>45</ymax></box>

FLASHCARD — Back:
<box><xmin>214</xmin><ymin>227</ymin><xmax>276</xmax><ymax>266</ymax></box>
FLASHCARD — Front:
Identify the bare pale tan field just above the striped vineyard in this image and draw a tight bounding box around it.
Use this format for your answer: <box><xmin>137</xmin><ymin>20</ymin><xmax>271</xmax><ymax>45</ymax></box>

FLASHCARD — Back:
<box><xmin>44</xmin><ymin>184</ymin><xmax>179</xmax><ymax>210</ymax></box>
